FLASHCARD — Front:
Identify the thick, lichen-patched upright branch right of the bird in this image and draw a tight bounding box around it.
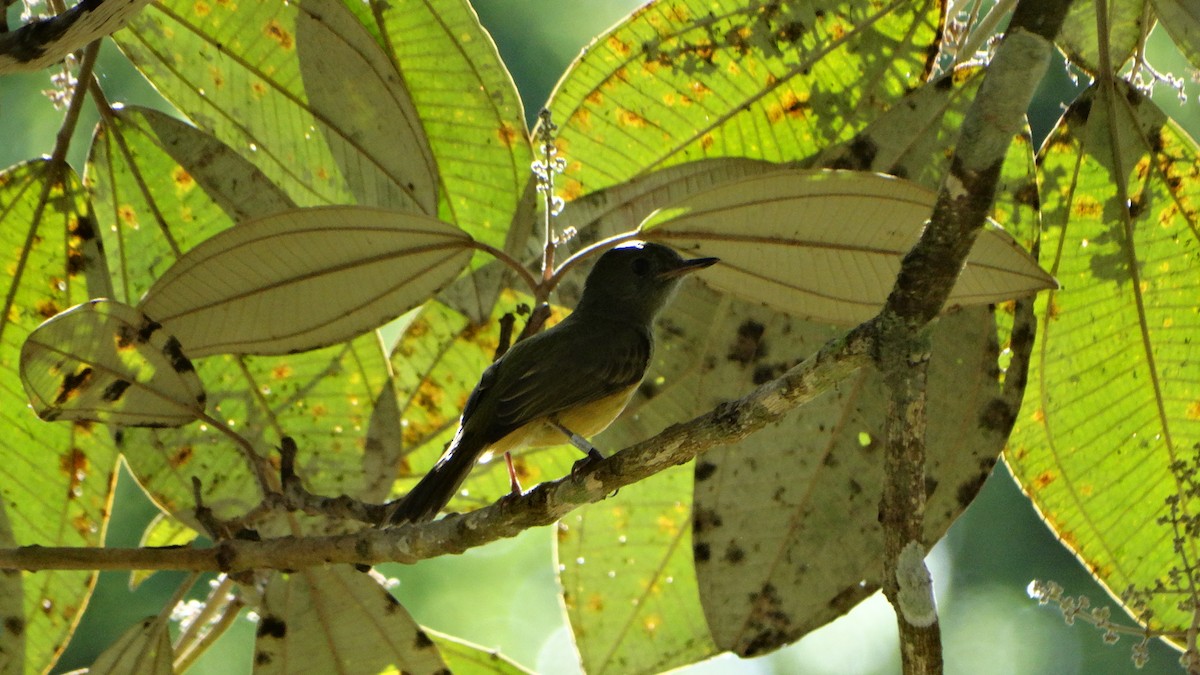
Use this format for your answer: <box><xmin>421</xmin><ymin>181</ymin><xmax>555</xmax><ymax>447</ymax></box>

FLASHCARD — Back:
<box><xmin>874</xmin><ymin>0</ymin><xmax>1070</xmax><ymax>674</ymax></box>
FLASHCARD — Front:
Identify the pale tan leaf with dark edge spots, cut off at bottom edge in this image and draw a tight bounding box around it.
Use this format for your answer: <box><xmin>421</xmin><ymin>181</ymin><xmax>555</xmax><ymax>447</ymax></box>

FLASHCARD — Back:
<box><xmin>254</xmin><ymin>566</ymin><xmax>446</xmax><ymax>675</ymax></box>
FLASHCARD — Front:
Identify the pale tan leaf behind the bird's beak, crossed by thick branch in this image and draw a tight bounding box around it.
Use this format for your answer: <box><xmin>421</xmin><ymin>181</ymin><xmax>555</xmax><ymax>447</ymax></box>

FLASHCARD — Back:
<box><xmin>647</xmin><ymin>169</ymin><xmax>1055</xmax><ymax>325</ymax></box>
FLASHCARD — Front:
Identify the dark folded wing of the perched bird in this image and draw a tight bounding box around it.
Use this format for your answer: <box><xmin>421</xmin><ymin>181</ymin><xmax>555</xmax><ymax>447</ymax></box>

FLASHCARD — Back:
<box><xmin>484</xmin><ymin>325</ymin><xmax>650</xmax><ymax>442</ymax></box>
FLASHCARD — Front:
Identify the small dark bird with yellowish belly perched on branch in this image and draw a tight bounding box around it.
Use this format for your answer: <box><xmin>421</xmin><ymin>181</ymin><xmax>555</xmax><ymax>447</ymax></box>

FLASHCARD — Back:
<box><xmin>390</xmin><ymin>241</ymin><xmax>719</xmax><ymax>525</ymax></box>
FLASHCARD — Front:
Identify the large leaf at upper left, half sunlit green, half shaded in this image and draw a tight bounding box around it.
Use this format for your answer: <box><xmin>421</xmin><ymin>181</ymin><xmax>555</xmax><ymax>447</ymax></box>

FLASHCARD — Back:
<box><xmin>115</xmin><ymin>0</ymin><xmax>437</xmax><ymax>214</ymax></box>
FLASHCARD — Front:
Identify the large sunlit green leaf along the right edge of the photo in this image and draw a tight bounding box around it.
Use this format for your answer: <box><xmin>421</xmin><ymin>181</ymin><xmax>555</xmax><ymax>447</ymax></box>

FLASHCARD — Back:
<box><xmin>1006</xmin><ymin>80</ymin><xmax>1200</xmax><ymax>633</ymax></box>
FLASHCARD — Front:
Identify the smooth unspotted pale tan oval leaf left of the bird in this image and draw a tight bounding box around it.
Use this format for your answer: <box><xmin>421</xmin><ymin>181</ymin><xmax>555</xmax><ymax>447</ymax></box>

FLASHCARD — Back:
<box><xmin>140</xmin><ymin>207</ymin><xmax>472</xmax><ymax>357</ymax></box>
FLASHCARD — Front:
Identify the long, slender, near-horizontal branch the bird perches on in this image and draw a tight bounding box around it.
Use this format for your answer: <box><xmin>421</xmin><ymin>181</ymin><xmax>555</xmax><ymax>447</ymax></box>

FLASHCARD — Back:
<box><xmin>0</xmin><ymin>323</ymin><xmax>874</xmax><ymax>572</ymax></box>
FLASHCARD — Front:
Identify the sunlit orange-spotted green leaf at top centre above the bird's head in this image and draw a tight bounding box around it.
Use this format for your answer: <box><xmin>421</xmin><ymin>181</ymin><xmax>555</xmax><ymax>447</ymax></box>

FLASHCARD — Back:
<box><xmin>550</xmin><ymin>0</ymin><xmax>942</xmax><ymax>201</ymax></box>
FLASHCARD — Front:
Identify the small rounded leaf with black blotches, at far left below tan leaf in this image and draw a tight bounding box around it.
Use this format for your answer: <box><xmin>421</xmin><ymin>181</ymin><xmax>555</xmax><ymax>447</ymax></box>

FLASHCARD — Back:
<box><xmin>20</xmin><ymin>299</ymin><xmax>205</xmax><ymax>426</ymax></box>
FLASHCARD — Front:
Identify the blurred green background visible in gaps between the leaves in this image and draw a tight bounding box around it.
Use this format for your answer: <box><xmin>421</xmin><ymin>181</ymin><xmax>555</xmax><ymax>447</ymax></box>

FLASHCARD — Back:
<box><xmin>0</xmin><ymin>0</ymin><xmax>1200</xmax><ymax>675</ymax></box>
